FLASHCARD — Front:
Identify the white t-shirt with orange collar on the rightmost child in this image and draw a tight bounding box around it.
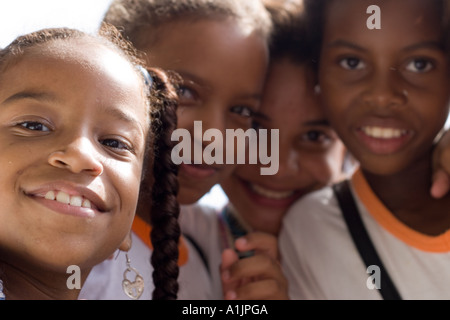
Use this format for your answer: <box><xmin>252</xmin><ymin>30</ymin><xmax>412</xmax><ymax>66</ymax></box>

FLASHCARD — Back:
<box><xmin>279</xmin><ymin>171</ymin><xmax>450</xmax><ymax>300</ymax></box>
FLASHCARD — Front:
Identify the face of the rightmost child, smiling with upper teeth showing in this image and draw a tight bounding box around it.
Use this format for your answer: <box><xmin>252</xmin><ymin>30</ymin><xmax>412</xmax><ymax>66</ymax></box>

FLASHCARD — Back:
<box><xmin>319</xmin><ymin>0</ymin><xmax>450</xmax><ymax>174</ymax></box>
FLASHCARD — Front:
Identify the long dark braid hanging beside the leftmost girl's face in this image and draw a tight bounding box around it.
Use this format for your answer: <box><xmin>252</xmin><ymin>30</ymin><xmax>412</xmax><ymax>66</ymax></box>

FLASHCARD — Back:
<box><xmin>150</xmin><ymin>69</ymin><xmax>180</xmax><ymax>300</ymax></box>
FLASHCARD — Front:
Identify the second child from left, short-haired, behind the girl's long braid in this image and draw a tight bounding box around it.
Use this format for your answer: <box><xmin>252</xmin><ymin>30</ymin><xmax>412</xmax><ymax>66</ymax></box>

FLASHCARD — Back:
<box><xmin>83</xmin><ymin>0</ymin><xmax>271</xmax><ymax>299</ymax></box>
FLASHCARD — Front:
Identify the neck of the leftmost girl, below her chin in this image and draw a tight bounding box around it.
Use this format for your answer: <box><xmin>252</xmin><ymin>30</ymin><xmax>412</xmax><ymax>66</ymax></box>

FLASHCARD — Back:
<box><xmin>0</xmin><ymin>261</ymin><xmax>86</xmax><ymax>300</ymax></box>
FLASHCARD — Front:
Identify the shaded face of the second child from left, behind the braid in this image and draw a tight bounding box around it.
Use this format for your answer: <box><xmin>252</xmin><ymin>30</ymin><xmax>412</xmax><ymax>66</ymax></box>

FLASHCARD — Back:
<box><xmin>145</xmin><ymin>20</ymin><xmax>268</xmax><ymax>204</ymax></box>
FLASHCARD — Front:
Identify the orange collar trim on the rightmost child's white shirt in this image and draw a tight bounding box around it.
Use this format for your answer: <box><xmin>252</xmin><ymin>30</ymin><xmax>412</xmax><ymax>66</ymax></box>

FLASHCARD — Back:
<box><xmin>352</xmin><ymin>169</ymin><xmax>450</xmax><ymax>253</ymax></box>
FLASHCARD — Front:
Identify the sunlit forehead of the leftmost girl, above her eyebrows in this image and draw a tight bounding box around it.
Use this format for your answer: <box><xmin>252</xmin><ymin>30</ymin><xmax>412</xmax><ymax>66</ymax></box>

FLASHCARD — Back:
<box><xmin>0</xmin><ymin>39</ymin><xmax>148</xmax><ymax>126</ymax></box>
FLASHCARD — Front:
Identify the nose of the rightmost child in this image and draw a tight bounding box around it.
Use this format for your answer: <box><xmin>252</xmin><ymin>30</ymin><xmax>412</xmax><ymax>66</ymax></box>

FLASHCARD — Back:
<box><xmin>364</xmin><ymin>68</ymin><xmax>408</xmax><ymax>108</ymax></box>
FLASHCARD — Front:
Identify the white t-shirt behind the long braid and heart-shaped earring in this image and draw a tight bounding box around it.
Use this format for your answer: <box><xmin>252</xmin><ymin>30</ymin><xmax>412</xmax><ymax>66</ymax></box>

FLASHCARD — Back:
<box><xmin>79</xmin><ymin>215</ymin><xmax>212</xmax><ymax>300</ymax></box>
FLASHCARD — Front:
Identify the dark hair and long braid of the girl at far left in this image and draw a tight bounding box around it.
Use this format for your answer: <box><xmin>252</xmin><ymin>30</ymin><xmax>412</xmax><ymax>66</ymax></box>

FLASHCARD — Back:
<box><xmin>0</xmin><ymin>23</ymin><xmax>180</xmax><ymax>299</ymax></box>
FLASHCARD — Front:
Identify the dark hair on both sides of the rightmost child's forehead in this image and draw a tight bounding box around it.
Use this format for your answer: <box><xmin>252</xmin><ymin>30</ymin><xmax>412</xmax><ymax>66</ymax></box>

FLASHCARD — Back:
<box><xmin>304</xmin><ymin>0</ymin><xmax>450</xmax><ymax>64</ymax></box>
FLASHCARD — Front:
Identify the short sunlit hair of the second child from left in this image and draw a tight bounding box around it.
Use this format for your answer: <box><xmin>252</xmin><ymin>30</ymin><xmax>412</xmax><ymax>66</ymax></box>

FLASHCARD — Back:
<box><xmin>104</xmin><ymin>0</ymin><xmax>271</xmax><ymax>50</ymax></box>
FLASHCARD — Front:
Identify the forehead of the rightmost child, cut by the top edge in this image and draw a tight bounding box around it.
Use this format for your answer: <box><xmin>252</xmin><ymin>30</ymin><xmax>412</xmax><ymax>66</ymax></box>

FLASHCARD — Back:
<box><xmin>325</xmin><ymin>0</ymin><xmax>442</xmax><ymax>34</ymax></box>
